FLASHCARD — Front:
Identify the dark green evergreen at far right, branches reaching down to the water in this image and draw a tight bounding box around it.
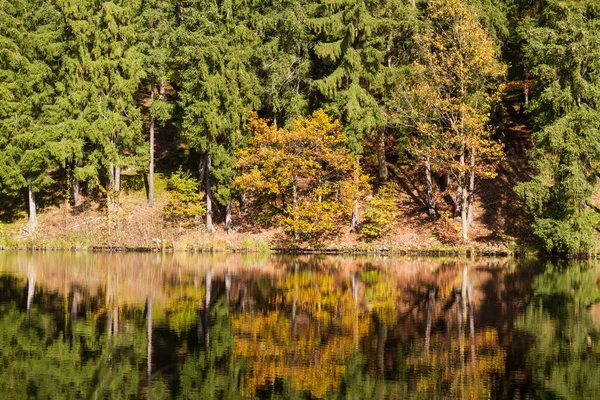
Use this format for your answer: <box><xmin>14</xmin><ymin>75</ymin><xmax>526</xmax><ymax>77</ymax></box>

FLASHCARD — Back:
<box><xmin>517</xmin><ymin>0</ymin><xmax>600</xmax><ymax>253</ymax></box>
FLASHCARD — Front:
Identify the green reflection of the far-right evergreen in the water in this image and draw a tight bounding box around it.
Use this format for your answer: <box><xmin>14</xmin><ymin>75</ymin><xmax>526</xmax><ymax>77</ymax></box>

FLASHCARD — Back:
<box><xmin>517</xmin><ymin>262</ymin><xmax>600</xmax><ymax>399</ymax></box>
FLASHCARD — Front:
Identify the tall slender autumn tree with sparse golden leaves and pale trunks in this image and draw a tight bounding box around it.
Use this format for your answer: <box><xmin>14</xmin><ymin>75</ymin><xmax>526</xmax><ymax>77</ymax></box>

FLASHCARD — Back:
<box><xmin>408</xmin><ymin>0</ymin><xmax>504</xmax><ymax>240</ymax></box>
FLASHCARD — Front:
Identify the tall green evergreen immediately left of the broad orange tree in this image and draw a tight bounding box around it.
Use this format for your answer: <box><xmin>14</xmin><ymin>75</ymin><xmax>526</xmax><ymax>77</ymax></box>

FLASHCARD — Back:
<box><xmin>178</xmin><ymin>0</ymin><xmax>260</xmax><ymax>232</ymax></box>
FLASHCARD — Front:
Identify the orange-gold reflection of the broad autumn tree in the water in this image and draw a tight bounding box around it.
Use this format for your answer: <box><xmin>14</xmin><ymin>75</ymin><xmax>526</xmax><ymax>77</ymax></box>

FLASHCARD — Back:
<box><xmin>232</xmin><ymin>271</ymin><xmax>370</xmax><ymax>397</ymax></box>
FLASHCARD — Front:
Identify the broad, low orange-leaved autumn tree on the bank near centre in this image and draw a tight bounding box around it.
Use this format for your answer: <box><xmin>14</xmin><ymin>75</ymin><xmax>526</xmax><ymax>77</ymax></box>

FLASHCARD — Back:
<box><xmin>235</xmin><ymin>110</ymin><xmax>366</xmax><ymax>239</ymax></box>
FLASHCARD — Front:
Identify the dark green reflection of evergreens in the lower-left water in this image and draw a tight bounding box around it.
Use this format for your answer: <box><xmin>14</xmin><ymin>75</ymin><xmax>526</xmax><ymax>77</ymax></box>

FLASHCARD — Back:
<box><xmin>0</xmin><ymin>288</ymin><xmax>146</xmax><ymax>399</ymax></box>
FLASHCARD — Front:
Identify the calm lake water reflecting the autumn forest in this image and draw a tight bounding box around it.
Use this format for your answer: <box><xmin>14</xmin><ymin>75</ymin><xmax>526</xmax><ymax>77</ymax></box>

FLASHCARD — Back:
<box><xmin>0</xmin><ymin>252</ymin><xmax>600</xmax><ymax>399</ymax></box>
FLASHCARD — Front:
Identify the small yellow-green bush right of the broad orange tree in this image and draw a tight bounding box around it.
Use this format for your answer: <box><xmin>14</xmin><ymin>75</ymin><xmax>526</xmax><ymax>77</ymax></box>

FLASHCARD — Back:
<box><xmin>360</xmin><ymin>182</ymin><xmax>400</xmax><ymax>238</ymax></box>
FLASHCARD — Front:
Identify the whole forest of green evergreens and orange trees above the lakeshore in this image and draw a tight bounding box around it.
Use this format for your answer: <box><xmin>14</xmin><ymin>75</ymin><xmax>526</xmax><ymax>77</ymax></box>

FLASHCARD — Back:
<box><xmin>0</xmin><ymin>0</ymin><xmax>600</xmax><ymax>254</ymax></box>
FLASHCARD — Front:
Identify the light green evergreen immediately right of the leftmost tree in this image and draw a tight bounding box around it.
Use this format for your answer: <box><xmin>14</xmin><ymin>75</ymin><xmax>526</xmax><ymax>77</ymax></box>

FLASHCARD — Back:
<box><xmin>58</xmin><ymin>0</ymin><xmax>146</xmax><ymax>198</ymax></box>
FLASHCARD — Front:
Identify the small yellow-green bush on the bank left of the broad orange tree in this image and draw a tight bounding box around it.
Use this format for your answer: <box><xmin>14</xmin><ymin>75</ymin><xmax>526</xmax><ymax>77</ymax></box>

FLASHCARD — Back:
<box><xmin>163</xmin><ymin>170</ymin><xmax>206</xmax><ymax>226</ymax></box>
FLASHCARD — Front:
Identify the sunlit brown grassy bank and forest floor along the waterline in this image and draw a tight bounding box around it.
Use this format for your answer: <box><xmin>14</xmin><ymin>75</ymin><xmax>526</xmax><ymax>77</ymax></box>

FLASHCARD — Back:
<box><xmin>0</xmin><ymin>153</ymin><xmax>532</xmax><ymax>254</ymax></box>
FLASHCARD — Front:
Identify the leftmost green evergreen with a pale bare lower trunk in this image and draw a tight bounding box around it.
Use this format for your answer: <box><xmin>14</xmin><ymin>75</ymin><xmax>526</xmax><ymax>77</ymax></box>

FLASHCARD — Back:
<box><xmin>0</xmin><ymin>0</ymin><xmax>62</xmax><ymax>232</ymax></box>
